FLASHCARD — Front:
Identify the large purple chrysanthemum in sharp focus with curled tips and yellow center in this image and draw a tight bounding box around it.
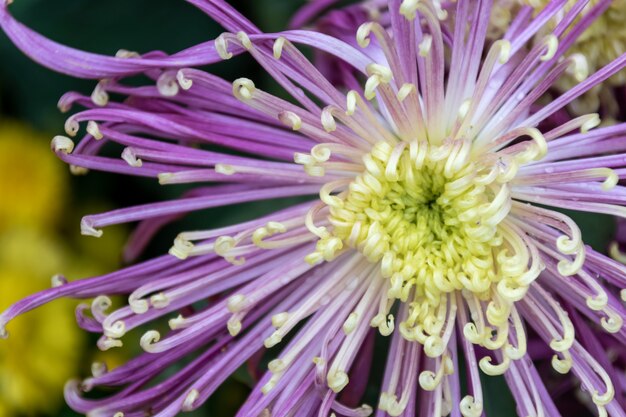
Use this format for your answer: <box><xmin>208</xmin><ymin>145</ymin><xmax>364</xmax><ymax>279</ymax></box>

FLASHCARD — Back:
<box><xmin>0</xmin><ymin>0</ymin><xmax>626</xmax><ymax>417</ymax></box>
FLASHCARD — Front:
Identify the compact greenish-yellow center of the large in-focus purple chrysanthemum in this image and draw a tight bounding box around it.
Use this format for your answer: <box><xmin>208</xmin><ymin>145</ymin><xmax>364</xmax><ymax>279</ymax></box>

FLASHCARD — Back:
<box><xmin>330</xmin><ymin>142</ymin><xmax>510</xmax><ymax>296</ymax></box>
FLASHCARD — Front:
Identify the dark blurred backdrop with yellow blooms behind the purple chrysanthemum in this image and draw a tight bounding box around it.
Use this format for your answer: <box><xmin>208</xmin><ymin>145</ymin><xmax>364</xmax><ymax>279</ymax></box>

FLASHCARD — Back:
<box><xmin>0</xmin><ymin>0</ymin><xmax>613</xmax><ymax>417</ymax></box>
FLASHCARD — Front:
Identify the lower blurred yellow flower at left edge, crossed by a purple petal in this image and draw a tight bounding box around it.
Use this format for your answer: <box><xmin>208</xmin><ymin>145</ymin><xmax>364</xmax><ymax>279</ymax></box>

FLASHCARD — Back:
<box><xmin>0</xmin><ymin>228</ymin><xmax>84</xmax><ymax>417</ymax></box>
